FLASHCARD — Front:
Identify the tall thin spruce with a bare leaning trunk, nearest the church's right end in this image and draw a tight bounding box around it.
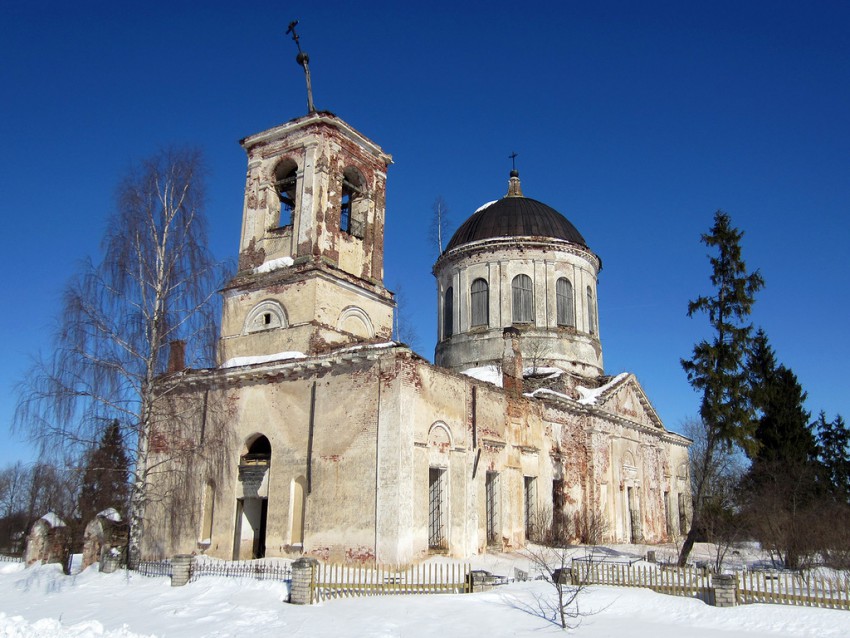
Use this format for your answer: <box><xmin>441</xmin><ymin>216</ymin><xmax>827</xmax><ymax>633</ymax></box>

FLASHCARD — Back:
<box><xmin>679</xmin><ymin>211</ymin><xmax>764</xmax><ymax>565</ymax></box>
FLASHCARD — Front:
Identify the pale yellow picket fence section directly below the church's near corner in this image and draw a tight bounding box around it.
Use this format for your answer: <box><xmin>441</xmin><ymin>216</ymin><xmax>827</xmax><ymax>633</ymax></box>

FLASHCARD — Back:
<box><xmin>312</xmin><ymin>563</ymin><xmax>472</xmax><ymax>601</ymax></box>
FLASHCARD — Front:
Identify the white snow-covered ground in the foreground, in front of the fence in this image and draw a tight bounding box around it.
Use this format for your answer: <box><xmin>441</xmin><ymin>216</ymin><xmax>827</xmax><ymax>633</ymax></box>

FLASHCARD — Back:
<box><xmin>0</xmin><ymin>556</ymin><xmax>850</xmax><ymax>638</ymax></box>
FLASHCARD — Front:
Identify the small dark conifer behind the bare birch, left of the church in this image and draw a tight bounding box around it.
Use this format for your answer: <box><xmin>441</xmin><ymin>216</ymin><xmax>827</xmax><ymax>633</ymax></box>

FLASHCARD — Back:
<box><xmin>80</xmin><ymin>419</ymin><xmax>129</xmax><ymax>525</ymax></box>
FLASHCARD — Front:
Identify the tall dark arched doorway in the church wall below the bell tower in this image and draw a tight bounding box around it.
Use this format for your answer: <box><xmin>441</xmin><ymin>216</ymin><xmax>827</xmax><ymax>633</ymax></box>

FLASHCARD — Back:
<box><xmin>233</xmin><ymin>434</ymin><xmax>272</xmax><ymax>560</ymax></box>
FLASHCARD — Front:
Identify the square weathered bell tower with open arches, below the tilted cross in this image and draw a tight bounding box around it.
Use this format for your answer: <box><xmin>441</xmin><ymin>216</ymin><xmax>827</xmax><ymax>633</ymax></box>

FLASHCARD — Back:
<box><xmin>219</xmin><ymin>111</ymin><xmax>395</xmax><ymax>362</ymax></box>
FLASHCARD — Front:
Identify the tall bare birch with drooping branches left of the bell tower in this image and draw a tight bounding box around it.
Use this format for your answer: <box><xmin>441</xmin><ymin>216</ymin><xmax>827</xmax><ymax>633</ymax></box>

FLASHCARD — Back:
<box><xmin>15</xmin><ymin>150</ymin><xmax>223</xmax><ymax>564</ymax></box>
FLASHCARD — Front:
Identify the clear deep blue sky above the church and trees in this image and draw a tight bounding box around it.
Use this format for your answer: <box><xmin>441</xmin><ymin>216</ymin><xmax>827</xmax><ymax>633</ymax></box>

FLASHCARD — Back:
<box><xmin>0</xmin><ymin>0</ymin><xmax>850</xmax><ymax>465</ymax></box>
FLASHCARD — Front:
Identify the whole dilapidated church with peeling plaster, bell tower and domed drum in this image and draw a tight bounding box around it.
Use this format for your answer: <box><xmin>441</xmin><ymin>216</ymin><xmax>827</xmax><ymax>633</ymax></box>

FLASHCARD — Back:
<box><xmin>143</xmin><ymin>111</ymin><xmax>690</xmax><ymax>563</ymax></box>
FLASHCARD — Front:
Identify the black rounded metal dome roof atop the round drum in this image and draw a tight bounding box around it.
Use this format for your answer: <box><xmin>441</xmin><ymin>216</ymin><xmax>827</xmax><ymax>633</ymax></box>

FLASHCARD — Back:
<box><xmin>446</xmin><ymin>196</ymin><xmax>587</xmax><ymax>251</ymax></box>
